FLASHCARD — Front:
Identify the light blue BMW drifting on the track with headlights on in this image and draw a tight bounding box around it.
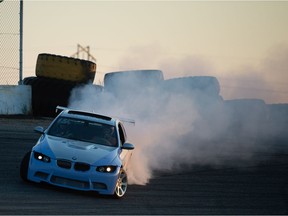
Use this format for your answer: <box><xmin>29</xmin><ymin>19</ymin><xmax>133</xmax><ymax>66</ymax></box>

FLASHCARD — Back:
<box><xmin>20</xmin><ymin>107</ymin><xmax>134</xmax><ymax>198</ymax></box>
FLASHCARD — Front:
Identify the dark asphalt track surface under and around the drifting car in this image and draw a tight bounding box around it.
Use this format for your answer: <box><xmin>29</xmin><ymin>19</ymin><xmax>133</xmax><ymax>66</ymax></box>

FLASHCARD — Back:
<box><xmin>0</xmin><ymin>117</ymin><xmax>288</xmax><ymax>215</ymax></box>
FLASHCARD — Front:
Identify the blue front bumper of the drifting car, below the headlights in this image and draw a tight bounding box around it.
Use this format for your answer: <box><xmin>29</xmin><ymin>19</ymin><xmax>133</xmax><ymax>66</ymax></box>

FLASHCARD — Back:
<box><xmin>27</xmin><ymin>152</ymin><xmax>120</xmax><ymax>195</ymax></box>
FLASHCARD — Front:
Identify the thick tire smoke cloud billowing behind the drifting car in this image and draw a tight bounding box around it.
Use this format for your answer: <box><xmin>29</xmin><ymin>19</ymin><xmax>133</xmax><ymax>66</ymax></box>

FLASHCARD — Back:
<box><xmin>69</xmin><ymin>70</ymin><xmax>282</xmax><ymax>185</ymax></box>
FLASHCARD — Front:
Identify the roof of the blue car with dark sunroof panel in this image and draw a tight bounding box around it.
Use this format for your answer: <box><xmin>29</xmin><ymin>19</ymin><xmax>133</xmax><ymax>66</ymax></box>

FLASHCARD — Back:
<box><xmin>59</xmin><ymin>108</ymin><xmax>119</xmax><ymax>125</ymax></box>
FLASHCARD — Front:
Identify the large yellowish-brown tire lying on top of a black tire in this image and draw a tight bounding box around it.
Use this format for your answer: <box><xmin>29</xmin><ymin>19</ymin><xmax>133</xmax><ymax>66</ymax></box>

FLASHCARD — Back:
<box><xmin>36</xmin><ymin>53</ymin><xmax>96</xmax><ymax>83</ymax></box>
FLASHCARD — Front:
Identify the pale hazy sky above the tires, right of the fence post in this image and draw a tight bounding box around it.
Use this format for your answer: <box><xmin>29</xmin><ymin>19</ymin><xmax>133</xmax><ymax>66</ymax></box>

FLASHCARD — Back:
<box><xmin>8</xmin><ymin>0</ymin><xmax>288</xmax><ymax>103</ymax></box>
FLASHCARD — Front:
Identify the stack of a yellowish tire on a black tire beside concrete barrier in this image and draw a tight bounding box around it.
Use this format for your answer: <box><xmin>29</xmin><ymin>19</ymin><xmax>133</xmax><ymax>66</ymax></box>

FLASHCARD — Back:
<box><xmin>23</xmin><ymin>53</ymin><xmax>96</xmax><ymax>117</ymax></box>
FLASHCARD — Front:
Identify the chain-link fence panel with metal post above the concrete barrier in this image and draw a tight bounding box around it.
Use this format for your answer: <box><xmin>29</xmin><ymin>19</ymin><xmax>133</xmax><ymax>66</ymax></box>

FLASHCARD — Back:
<box><xmin>0</xmin><ymin>0</ymin><xmax>20</xmax><ymax>85</ymax></box>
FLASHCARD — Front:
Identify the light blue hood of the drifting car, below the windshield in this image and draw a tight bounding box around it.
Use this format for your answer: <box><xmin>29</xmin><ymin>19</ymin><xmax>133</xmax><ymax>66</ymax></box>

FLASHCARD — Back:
<box><xmin>37</xmin><ymin>135</ymin><xmax>118</xmax><ymax>164</ymax></box>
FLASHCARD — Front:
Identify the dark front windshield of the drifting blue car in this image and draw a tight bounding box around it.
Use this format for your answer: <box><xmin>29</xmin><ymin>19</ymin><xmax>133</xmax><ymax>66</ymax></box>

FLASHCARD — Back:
<box><xmin>47</xmin><ymin>117</ymin><xmax>117</xmax><ymax>147</ymax></box>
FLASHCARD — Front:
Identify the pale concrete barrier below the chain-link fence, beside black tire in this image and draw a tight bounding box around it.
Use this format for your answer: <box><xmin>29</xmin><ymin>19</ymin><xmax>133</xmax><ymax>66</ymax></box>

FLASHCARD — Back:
<box><xmin>0</xmin><ymin>85</ymin><xmax>32</xmax><ymax>115</ymax></box>
